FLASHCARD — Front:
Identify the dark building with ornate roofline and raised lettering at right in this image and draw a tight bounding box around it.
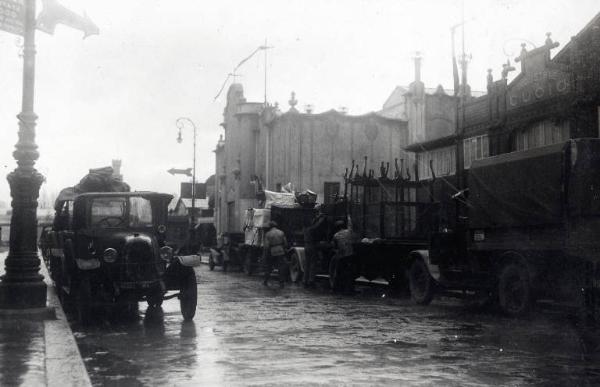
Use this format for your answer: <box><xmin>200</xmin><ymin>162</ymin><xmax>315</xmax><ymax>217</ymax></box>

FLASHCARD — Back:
<box><xmin>407</xmin><ymin>14</ymin><xmax>600</xmax><ymax>179</ymax></box>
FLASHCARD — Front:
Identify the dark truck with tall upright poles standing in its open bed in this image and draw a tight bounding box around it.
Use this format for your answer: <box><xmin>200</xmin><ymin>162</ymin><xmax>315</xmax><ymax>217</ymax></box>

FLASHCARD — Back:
<box><xmin>290</xmin><ymin>158</ymin><xmax>439</xmax><ymax>290</ymax></box>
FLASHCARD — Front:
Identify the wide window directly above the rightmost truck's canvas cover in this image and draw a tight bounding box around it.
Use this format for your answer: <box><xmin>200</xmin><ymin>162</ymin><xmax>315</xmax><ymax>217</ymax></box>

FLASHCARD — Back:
<box><xmin>514</xmin><ymin>120</ymin><xmax>569</xmax><ymax>151</ymax></box>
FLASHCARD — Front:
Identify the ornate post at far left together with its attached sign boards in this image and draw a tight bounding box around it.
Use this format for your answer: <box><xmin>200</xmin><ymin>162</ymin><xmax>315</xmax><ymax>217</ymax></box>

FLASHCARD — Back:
<box><xmin>0</xmin><ymin>0</ymin><xmax>97</xmax><ymax>313</ymax></box>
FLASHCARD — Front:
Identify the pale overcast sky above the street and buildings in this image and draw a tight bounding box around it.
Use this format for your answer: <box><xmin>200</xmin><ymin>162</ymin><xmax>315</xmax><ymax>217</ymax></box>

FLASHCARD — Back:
<box><xmin>0</xmin><ymin>0</ymin><xmax>600</xmax><ymax>206</ymax></box>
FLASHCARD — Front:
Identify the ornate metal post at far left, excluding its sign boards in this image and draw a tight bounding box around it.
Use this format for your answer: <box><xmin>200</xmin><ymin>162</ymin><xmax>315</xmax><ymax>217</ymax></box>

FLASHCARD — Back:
<box><xmin>0</xmin><ymin>0</ymin><xmax>46</xmax><ymax>309</ymax></box>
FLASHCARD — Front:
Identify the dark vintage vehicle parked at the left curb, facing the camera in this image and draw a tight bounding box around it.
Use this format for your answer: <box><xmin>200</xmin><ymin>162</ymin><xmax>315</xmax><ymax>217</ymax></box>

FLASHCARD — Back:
<box><xmin>40</xmin><ymin>171</ymin><xmax>199</xmax><ymax>323</ymax></box>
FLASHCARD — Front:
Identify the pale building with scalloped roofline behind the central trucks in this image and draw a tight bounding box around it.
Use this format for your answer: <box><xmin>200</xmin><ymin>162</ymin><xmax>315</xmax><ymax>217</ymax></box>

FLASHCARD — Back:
<box><xmin>215</xmin><ymin>84</ymin><xmax>408</xmax><ymax>232</ymax></box>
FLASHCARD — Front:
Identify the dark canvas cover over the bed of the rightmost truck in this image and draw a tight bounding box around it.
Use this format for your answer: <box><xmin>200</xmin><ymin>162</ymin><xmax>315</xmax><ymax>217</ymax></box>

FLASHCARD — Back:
<box><xmin>468</xmin><ymin>141</ymin><xmax>571</xmax><ymax>228</ymax></box>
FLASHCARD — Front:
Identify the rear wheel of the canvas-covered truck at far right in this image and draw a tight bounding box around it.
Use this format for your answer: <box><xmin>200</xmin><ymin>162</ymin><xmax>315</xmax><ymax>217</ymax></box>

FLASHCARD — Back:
<box><xmin>498</xmin><ymin>263</ymin><xmax>533</xmax><ymax>317</ymax></box>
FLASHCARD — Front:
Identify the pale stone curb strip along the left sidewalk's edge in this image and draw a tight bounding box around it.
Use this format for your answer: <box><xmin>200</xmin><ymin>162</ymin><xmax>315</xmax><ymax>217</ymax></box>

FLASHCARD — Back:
<box><xmin>40</xmin><ymin>260</ymin><xmax>92</xmax><ymax>387</ymax></box>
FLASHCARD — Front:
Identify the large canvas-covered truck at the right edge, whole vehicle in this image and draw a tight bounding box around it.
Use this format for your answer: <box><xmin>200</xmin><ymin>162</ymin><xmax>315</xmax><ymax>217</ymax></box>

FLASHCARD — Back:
<box><xmin>408</xmin><ymin>139</ymin><xmax>600</xmax><ymax>315</ymax></box>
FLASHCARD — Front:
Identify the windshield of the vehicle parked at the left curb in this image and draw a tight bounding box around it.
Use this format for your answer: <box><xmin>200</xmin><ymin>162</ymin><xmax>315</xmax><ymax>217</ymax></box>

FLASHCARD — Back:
<box><xmin>90</xmin><ymin>196</ymin><xmax>152</xmax><ymax>228</ymax></box>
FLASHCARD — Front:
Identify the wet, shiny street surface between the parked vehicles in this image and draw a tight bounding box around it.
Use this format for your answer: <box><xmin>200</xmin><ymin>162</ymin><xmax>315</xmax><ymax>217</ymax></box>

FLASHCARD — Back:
<box><xmin>73</xmin><ymin>266</ymin><xmax>600</xmax><ymax>386</ymax></box>
